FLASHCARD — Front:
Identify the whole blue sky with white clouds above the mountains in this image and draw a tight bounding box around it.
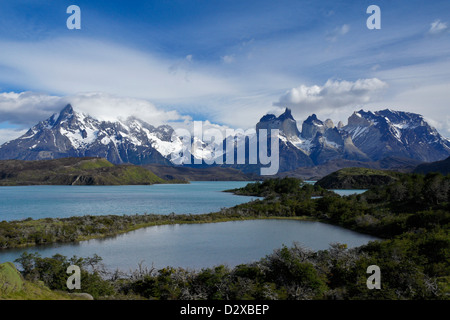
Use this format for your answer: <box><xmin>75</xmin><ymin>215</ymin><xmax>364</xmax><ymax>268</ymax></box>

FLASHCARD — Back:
<box><xmin>0</xmin><ymin>0</ymin><xmax>450</xmax><ymax>142</ymax></box>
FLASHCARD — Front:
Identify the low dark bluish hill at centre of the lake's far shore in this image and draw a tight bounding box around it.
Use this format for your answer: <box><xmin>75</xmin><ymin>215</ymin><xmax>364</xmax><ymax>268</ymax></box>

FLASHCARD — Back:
<box><xmin>142</xmin><ymin>164</ymin><xmax>261</xmax><ymax>181</ymax></box>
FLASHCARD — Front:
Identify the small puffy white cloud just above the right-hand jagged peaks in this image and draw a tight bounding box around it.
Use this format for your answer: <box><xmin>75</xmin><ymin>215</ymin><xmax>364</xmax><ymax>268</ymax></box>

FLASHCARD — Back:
<box><xmin>274</xmin><ymin>78</ymin><xmax>387</xmax><ymax>112</ymax></box>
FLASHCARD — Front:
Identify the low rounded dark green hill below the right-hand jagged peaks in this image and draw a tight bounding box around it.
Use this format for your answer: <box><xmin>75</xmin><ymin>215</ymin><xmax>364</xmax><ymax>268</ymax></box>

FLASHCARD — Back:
<box><xmin>316</xmin><ymin>168</ymin><xmax>401</xmax><ymax>189</ymax></box>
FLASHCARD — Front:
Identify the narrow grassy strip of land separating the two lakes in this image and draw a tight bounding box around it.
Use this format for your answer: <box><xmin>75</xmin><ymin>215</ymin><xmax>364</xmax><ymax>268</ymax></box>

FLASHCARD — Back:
<box><xmin>0</xmin><ymin>180</ymin><xmax>383</xmax><ymax>253</ymax></box>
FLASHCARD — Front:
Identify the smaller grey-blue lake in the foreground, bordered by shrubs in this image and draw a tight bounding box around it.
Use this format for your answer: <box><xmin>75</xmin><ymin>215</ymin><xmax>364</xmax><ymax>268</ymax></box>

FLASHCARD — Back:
<box><xmin>0</xmin><ymin>220</ymin><xmax>377</xmax><ymax>271</ymax></box>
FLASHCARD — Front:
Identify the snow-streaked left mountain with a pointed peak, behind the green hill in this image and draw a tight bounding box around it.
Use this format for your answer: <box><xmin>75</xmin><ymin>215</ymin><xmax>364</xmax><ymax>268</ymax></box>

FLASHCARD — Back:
<box><xmin>0</xmin><ymin>105</ymin><xmax>180</xmax><ymax>164</ymax></box>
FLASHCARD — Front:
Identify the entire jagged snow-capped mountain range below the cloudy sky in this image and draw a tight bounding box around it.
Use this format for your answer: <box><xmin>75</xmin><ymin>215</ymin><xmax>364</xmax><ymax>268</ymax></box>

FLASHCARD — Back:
<box><xmin>0</xmin><ymin>105</ymin><xmax>450</xmax><ymax>176</ymax></box>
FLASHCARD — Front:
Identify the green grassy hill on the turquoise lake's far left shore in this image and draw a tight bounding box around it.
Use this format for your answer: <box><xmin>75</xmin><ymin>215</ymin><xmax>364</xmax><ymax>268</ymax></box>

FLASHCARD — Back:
<box><xmin>0</xmin><ymin>158</ymin><xmax>166</xmax><ymax>186</ymax></box>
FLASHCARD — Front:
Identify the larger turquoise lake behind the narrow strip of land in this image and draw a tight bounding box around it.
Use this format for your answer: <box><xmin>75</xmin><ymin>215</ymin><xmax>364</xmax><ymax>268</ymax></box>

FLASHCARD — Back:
<box><xmin>0</xmin><ymin>181</ymin><xmax>258</xmax><ymax>221</ymax></box>
